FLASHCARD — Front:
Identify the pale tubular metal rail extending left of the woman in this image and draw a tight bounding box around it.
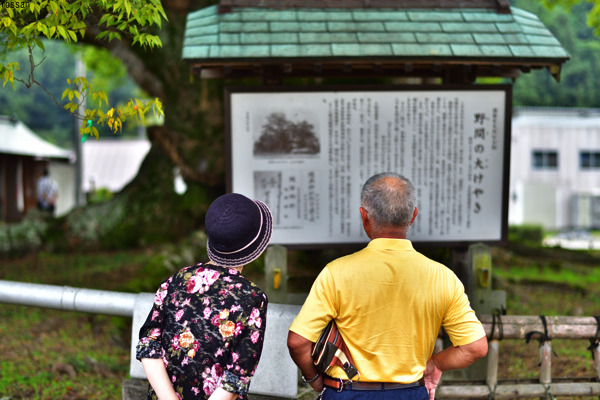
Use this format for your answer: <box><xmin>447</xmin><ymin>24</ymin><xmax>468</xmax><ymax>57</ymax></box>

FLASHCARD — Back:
<box><xmin>0</xmin><ymin>280</ymin><xmax>137</xmax><ymax>317</ymax></box>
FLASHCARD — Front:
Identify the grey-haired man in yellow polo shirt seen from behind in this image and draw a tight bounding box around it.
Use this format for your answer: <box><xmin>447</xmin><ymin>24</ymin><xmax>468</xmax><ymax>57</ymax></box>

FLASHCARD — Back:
<box><xmin>288</xmin><ymin>173</ymin><xmax>487</xmax><ymax>400</ymax></box>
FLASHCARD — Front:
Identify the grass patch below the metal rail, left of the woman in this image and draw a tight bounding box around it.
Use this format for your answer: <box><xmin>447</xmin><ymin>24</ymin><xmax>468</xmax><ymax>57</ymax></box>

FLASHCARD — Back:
<box><xmin>0</xmin><ymin>305</ymin><xmax>129</xmax><ymax>400</ymax></box>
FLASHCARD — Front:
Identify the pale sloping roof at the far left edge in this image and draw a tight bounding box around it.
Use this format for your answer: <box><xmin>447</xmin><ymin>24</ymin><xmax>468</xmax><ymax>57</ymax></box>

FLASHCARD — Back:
<box><xmin>0</xmin><ymin>116</ymin><xmax>74</xmax><ymax>159</ymax></box>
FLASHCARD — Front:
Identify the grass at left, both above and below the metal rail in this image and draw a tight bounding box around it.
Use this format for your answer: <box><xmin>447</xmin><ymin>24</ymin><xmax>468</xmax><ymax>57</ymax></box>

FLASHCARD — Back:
<box><xmin>0</xmin><ymin>250</ymin><xmax>158</xmax><ymax>400</ymax></box>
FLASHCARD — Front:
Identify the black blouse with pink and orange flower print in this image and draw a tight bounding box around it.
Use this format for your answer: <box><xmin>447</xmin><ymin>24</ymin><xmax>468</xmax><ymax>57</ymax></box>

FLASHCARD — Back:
<box><xmin>136</xmin><ymin>264</ymin><xmax>267</xmax><ymax>400</ymax></box>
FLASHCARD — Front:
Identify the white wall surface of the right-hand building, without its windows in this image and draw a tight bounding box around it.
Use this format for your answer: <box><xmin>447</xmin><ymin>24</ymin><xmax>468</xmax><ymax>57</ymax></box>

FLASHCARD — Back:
<box><xmin>509</xmin><ymin>109</ymin><xmax>600</xmax><ymax>229</ymax></box>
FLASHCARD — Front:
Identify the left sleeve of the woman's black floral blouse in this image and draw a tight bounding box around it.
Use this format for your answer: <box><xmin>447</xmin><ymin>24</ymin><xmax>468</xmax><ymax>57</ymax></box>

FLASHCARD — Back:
<box><xmin>135</xmin><ymin>278</ymin><xmax>172</xmax><ymax>360</ymax></box>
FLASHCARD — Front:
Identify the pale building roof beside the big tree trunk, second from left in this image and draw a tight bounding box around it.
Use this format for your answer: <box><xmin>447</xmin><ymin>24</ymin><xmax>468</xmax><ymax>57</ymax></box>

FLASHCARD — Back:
<box><xmin>81</xmin><ymin>138</ymin><xmax>151</xmax><ymax>192</ymax></box>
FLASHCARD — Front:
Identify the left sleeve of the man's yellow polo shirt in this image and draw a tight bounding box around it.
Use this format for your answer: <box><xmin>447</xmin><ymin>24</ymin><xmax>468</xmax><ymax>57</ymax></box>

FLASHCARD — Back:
<box><xmin>290</xmin><ymin>267</ymin><xmax>339</xmax><ymax>342</ymax></box>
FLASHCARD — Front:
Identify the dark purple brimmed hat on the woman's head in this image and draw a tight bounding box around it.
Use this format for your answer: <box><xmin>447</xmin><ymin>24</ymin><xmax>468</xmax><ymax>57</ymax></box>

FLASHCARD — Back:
<box><xmin>205</xmin><ymin>193</ymin><xmax>273</xmax><ymax>267</ymax></box>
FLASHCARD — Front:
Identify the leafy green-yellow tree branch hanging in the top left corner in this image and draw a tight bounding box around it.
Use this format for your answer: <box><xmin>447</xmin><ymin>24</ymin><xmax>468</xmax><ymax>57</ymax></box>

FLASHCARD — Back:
<box><xmin>0</xmin><ymin>0</ymin><xmax>167</xmax><ymax>138</ymax></box>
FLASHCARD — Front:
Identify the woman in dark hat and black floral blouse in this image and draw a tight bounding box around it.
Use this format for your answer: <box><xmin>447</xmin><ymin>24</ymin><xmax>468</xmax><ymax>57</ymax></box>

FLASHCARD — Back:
<box><xmin>136</xmin><ymin>193</ymin><xmax>272</xmax><ymax>400</ymax></box>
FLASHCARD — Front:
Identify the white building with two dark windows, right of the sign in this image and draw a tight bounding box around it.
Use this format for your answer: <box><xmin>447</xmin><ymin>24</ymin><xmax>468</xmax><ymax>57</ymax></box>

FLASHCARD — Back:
<box><xmin>509</xmin><ymin>107</ymin><xmax>600</xmax><ymax>229</ymax></box>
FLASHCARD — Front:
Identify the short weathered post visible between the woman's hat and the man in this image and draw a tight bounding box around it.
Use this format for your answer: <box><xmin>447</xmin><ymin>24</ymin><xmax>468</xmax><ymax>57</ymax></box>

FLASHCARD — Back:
<box><xmin>264</xmin><ymin>246</ymin><xmax>288</xmax><ymax>304</ymax></box>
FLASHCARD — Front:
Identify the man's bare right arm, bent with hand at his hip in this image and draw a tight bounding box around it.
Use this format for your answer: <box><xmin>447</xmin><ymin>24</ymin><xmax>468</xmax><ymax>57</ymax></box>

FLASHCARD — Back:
<box><xmin>423</xmin><ymin>336</ymin><xmax>487</xmax><ymax>400</ymax></box>
